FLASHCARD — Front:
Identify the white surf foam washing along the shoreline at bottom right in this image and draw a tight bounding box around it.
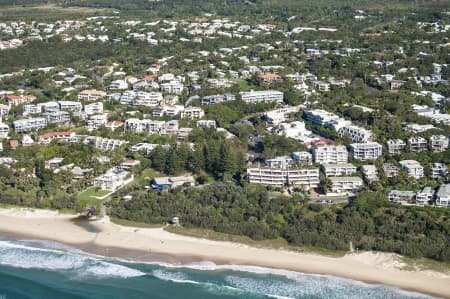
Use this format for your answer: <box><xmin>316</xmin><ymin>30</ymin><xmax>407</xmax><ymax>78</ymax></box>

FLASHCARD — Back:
<box><xmin>149</xmin><ymin>261</ymin><xmax>433</xmax><ymax>299</ymax></box>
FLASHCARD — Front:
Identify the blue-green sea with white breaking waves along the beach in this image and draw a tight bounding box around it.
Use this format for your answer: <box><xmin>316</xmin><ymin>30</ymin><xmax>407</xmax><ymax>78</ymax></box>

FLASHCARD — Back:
<box><xmin>0</xmin><ymin>240</ymin><xmax>438</xmax><ymax>299</ymax></box>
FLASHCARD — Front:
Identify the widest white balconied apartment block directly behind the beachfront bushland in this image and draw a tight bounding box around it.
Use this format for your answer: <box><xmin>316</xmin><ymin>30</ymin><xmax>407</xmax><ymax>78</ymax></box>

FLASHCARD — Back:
<box><xmin>247</xmin><ymin>167</ymin><xmax>320</xmax><ymax>190</ymax></box>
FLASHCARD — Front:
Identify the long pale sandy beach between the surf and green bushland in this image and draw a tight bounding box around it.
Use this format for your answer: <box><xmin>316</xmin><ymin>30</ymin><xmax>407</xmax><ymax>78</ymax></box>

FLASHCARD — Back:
<box><xmin>0</xmin><ymin>208</ymin><xmax>450</xmax><ymax>298</ymax></box>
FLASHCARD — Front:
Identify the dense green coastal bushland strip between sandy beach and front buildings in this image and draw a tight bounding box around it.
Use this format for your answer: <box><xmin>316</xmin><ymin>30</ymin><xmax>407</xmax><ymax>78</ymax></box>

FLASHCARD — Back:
<box><xmin>108</xmin><ymin>183</ymin><xmax>450</xmax><ymax>262</ymax></box>
